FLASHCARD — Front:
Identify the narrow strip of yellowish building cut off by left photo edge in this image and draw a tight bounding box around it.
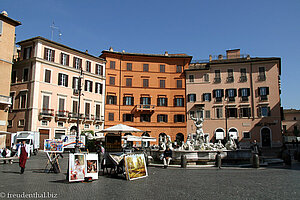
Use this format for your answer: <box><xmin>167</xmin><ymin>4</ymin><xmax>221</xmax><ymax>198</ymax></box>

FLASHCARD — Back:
<box><xmin>0</xmin><ymin>11</ymin><xmax>21</xmax><ymax>148</ymax></box>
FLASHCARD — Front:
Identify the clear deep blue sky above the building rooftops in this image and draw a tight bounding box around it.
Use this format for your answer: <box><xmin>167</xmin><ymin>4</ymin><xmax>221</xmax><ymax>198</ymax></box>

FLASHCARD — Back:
<box><xmin>0</xmin><ymin>0</ymin><xmax>300</xmax><ymax>109</ymax></box>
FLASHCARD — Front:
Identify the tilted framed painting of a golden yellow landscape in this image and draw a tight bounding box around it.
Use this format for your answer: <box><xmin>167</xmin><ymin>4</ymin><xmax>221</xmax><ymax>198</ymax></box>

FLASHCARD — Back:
<box><xmin>124</xmin><ymin>154</ymin><xmax>148</xmax><ymax>180</ymax></box>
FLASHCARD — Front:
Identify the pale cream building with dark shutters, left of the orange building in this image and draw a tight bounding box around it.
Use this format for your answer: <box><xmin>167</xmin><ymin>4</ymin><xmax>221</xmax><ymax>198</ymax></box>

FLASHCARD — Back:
<box><xmin>8</xmin><ymin>37</ymin><xmax>105</xmax><ymax>146</ymax></box>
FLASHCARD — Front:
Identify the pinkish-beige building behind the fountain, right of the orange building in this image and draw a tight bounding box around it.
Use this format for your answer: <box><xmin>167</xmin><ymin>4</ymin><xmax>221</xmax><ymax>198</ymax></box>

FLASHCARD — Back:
<box><xmin>185</xmin><ymin>49</ymin><xmax>282</xmax><ymax>147</ymax></box>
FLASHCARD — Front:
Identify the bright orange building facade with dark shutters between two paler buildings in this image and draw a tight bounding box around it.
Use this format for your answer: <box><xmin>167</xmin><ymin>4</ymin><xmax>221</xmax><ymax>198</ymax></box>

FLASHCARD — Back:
<box><xmin>100</xmin><ymin>49</ymin><xmax>192</xmax><ymax>142</ymax></box>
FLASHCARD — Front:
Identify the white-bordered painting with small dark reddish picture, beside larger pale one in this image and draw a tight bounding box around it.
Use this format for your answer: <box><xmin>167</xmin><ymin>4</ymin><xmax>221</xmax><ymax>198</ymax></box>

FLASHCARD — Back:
<box><xmin>85</xmin><ymin>153</ymin><xmax>99</xmax><ymax>179</ymax></box>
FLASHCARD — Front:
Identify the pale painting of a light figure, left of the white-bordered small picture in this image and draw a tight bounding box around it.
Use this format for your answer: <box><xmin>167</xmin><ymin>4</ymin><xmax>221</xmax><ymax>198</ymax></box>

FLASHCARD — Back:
<box><xmin>69</xmin><ymin>153</ymin><xmax>86</xmax><ymax>182</ymax></box>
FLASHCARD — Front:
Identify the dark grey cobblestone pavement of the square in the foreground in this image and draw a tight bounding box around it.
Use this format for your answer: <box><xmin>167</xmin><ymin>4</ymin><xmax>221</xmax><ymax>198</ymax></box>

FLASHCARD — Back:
<box><xmin>0</xmin><ymin>152</ymin><xmax>300</xmax><ymax>200</ymax></box>
